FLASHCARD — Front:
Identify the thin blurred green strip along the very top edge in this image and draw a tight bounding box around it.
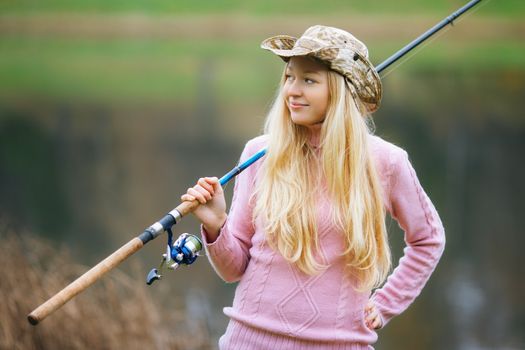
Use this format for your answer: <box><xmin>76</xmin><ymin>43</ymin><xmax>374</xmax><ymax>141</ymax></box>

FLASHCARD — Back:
<box><xmin>0</xmin><ymin>0</ymin><xmax>525</xmax><ymax>17</ymax></box>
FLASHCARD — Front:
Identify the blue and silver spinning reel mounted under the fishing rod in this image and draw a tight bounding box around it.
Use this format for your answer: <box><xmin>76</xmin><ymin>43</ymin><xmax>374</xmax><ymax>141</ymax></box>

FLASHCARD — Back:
<box><xmin>146</xmin><ymin>229</ymin><xmax>202</xmax><ymax>285</ymax></box>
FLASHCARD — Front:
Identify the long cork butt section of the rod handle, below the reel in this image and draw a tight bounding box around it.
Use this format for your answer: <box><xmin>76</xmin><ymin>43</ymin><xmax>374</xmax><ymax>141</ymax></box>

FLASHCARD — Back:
<box><xmin>27</xmin><ymin>237</ymin><xmax>144</xmax><ymax>325</ymax></box>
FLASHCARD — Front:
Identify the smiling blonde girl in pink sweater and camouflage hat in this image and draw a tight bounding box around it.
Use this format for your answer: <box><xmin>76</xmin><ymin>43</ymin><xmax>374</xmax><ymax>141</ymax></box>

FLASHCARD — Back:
<box><xmin>181</xmin><ymin>26</ymin><xmax>445</xmax><ymax>350</ymax></box>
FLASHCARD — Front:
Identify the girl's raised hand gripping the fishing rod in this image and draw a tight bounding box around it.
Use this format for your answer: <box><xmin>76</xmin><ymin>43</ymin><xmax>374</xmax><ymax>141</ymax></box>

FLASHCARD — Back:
<box><xmin>180</xmin><ymin>177</ymin><xmax>227</xmax><ymax>243</ymax></box>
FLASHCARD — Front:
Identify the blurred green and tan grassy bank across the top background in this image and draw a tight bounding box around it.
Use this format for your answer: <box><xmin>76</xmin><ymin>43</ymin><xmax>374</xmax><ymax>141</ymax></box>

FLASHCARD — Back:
<box><xmin>0</xmin><ymin>0</ymin><xmax>525</xmax><ymax>104</ymax></box>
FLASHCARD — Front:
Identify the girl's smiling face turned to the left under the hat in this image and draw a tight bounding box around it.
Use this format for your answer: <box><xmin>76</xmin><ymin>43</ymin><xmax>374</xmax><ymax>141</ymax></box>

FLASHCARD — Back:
<box><xmin>283</xmin><ymin>56</ymin><xmax>329</xmax><ymax>129</ymax></box>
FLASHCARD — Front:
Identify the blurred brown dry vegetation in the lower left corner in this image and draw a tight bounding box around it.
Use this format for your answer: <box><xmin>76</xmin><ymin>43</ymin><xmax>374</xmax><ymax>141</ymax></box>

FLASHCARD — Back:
<box><xmin>0</xmin><ymin>227</ymin><xmax>210</xmax><ymax>349</ymax></box>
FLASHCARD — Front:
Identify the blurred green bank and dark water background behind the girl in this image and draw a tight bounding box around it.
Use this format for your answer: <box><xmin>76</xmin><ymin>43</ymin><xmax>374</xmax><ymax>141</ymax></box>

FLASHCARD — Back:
<box><xmin>0</xmin><ymin>0</ymin><xmax>525</xmax><ymax>349</ymax></box>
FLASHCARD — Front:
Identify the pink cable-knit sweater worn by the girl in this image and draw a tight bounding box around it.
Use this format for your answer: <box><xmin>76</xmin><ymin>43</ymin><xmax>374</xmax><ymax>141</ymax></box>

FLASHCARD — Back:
<box><xmin>202</xmin><ymin>136</ymin><xmax>445</xmax><ymax>350</ymax></box>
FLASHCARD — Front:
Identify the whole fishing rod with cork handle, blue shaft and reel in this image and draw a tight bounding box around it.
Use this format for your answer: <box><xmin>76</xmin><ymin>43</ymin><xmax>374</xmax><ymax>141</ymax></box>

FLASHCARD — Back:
<box><xmin>27</xmin><ymin>0</ymin><xmax>481</xmax><ymax>325</ymax></box>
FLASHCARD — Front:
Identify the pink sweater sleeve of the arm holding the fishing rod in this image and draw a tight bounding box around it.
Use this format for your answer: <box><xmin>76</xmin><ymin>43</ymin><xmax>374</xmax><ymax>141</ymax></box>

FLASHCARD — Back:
<box><xmin>201</xmin><ymin>139</ymin><xmax>258</xmax><ymax>282</ymax></box>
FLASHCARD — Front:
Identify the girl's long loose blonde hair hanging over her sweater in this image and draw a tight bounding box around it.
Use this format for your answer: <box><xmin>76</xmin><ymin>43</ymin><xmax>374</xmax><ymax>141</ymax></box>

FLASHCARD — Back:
<box><xmin>255</xmin><ymin>67</ymin><xmax>391</xmax><ymax>291</ymax></box>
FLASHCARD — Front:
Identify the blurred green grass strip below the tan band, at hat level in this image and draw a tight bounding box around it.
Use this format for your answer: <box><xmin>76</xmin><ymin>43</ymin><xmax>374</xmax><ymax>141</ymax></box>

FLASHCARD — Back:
<box><xmin>0</xmin><ymin>37</ymin><xmax>525</xmax><ymax>103</ymax></box>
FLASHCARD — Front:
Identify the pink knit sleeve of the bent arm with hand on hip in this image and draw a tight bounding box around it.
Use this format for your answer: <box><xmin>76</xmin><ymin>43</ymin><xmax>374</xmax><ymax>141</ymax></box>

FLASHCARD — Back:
<box><xmin>372</xmin><ymin>149</ymin><xmax>445</xmax><ymax>326</ymax></box>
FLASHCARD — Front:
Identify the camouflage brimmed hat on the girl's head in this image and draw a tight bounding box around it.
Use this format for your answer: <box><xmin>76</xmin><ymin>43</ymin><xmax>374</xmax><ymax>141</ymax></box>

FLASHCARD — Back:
<box><xmin>261</xmin><ymin>25</ymin><xmax>382</xmax><ymax>112</ymax></box>
